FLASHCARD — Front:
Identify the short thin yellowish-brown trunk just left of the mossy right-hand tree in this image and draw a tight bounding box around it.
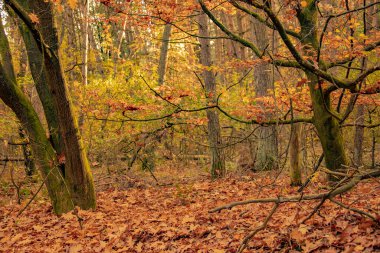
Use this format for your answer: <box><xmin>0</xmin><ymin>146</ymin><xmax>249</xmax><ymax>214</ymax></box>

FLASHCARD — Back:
<box><xmin>289</xmin><ymin>124</ymin><xmax>302</xmax><ymax>186</ymax></box>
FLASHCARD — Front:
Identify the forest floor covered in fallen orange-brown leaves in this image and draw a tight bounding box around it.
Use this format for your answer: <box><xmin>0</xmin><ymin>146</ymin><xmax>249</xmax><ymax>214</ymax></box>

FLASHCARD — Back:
<box><xmin>0</xmin><ymin>166</ymin><xmax>380</xmax><ymax>253</ymax></box>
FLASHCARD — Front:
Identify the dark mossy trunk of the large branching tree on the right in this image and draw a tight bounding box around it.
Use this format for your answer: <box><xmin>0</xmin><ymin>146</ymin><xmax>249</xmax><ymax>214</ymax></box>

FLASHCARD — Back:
<box><xmin>297</xmin><ymin>0</ymin><xmax>349</xmax><ymax>179</ymax></box>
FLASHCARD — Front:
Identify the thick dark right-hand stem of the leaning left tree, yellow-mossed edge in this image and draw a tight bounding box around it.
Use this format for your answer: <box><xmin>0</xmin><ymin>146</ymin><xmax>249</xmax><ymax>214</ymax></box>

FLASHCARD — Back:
<box><xmin>12</xmin><ymin>0</ymin><xmax>96</xmax><ymax>209</ymax></box>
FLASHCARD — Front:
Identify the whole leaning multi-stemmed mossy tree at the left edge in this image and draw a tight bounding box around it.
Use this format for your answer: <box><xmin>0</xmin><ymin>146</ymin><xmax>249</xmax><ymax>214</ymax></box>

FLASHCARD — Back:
<box><xmin>0</xmin><ymin>0</ymin><xmax>96</xmax><ymax>213</ymax></box>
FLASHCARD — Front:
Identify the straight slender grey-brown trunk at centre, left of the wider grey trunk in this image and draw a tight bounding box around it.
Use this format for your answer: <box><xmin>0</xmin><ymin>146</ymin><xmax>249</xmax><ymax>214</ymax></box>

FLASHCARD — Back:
<box><xmin>198</xmin><ymin>14</ymin><xmax>226</xmax><ymax>178</ymax></box>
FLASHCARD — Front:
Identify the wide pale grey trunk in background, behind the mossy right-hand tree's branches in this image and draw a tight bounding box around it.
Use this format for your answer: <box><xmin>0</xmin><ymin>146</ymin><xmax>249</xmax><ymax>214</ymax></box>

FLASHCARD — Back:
<box><xmin>252</xmin><ymin>17</ymin><xmax>278</xmax><ymax>170</ymax></box>
